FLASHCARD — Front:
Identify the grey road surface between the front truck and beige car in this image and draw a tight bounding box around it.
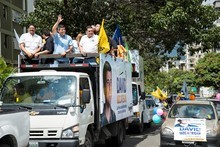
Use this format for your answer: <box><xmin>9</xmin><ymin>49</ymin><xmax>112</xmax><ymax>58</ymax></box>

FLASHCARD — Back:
<box><xmin>95</xmin><ymin>124</ymin><xmax>160</xmax><ymax>147</ymax></box>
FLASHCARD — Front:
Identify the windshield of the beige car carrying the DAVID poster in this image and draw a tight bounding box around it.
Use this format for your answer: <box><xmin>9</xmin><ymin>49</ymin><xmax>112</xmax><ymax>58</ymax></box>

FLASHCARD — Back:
<box><xmin>168</xmin><ymin>104</ymin><xmax>215</xmax><ymax>119</ymax></box>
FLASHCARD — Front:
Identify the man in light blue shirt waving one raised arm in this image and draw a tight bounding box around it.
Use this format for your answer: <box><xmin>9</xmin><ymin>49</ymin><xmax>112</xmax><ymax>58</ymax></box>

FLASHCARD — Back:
<box><xmin>52</xmin><ymin>15</ymin><xmax>73</xmax><ymax>64</ymax></box>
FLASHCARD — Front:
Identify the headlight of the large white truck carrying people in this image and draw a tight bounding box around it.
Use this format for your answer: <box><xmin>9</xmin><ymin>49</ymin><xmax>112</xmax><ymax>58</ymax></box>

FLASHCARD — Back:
<box><xmin>62</xmin><ymin>126</ymin><xmax>79</xmax><ymax>138</ymax></box>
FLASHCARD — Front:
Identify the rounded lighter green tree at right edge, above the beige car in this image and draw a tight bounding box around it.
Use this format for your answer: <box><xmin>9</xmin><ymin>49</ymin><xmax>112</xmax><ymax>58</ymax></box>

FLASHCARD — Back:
<box><xmin>195</xmin><ymin>52</ymin><xmax>220</xmax><ymax>89</ymax></box>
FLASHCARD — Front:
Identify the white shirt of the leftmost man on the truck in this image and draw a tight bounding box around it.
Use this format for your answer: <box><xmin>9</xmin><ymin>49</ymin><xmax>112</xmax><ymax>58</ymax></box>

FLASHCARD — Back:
<box><xmin>19</xmin><ymin>33</ymin><xmax>42</xmax><ymax>55</ymax></box>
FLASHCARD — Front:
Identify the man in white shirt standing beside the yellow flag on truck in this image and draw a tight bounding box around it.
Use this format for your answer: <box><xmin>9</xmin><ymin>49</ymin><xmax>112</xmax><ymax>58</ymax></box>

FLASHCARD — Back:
<box><xmin>79</xmin><ymin>26</ymin><xmax>98</xmax><ymax>63</ymax></box>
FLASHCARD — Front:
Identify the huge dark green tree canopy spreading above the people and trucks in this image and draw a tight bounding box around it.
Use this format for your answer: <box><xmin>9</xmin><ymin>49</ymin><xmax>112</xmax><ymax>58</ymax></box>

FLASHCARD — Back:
<box><xmin>22</xmin><ymin>0</ymin><xmax>220</xmax><ymax>90</ymax></box>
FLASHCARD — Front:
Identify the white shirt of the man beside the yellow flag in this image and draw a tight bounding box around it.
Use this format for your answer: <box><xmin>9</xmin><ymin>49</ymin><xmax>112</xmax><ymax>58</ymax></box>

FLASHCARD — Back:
<box><xmin>79</xmin><ymin>35</ymin><xmax>98</xmax><ymax>53</ymax></box>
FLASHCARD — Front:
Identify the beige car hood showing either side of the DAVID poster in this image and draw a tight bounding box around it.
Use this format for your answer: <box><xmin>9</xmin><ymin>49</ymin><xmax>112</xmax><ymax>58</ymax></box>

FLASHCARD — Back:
<box><xmin>161</xmin><ymin>118</ymin><xmax>218</xmax><ymax>131</ymax></box>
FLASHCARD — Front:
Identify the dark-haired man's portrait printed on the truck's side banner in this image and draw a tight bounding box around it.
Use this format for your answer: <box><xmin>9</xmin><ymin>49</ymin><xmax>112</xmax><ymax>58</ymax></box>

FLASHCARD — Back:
<box><xmin>101</xmin><ymin>61</ymin><xmax>116</xmax><ymax>126</ymax></box>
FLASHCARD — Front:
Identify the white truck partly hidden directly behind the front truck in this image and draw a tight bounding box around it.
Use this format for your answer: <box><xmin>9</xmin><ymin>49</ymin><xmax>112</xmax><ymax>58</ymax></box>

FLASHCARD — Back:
<box><xmin>128</xmin><ymin>50</ymin><xmax>150</xmax><ymax>133</ymax></box>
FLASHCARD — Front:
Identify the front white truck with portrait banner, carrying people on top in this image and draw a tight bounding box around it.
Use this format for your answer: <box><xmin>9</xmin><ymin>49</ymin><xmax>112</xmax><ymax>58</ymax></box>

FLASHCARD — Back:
<box><xmin>1</xmin><ymin>54</ymin><xmax>133</xmax><ymax>147</ymax></box>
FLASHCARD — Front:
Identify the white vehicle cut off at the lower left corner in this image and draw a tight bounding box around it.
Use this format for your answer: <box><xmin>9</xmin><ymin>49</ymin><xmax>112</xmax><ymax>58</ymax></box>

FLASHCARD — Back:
<box><xmin>0</xmin><ymin>108</ymin><xmax>30</xmax><ymax>147</ymax></box>
